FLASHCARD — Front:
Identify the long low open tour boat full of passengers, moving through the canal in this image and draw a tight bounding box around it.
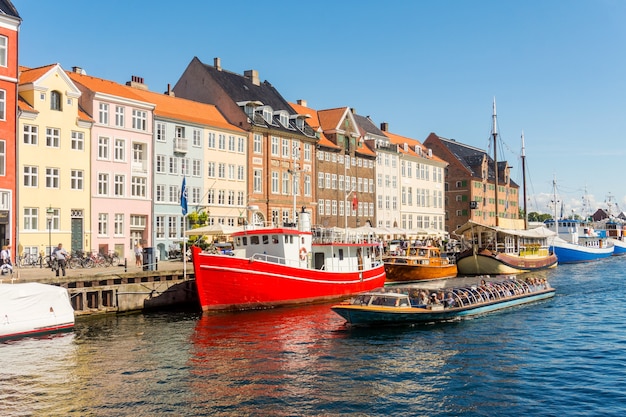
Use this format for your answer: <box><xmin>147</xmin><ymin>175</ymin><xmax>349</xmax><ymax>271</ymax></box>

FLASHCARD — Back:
<box><xmin>331</xmin><ymin>279</ymin><xmax>555</xmax><ymax>326</ymax></box>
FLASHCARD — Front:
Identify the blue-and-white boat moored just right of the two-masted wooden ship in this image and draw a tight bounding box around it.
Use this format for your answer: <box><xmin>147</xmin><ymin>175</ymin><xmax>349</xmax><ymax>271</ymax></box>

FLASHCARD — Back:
<box><xmin>545</xmin><ymin>179</ymin><xmax>615</xmax><ymax>263</ymax></box>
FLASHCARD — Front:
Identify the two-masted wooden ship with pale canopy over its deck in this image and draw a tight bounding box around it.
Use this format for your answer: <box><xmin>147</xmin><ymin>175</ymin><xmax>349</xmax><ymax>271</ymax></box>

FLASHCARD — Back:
<box><xmin>454</xmin><ymin>99</ymin><xmax>557</xmax><ymax>275</ymax></box>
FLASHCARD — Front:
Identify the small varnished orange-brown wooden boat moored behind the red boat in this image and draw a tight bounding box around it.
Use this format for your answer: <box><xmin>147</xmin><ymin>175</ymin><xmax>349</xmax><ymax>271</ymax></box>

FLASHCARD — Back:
<box><xmin>383</xmin><ymin>246</ymin><xmax>457</xmax><ymax>283</ymax></box>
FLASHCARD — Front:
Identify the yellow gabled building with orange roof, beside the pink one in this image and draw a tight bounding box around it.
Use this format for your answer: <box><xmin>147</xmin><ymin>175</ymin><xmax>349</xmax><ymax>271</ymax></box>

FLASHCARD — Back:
<box><xmin>15</xmin><ymin>64</ymin><xmax>93</xmax><ymax>255</ymax></box>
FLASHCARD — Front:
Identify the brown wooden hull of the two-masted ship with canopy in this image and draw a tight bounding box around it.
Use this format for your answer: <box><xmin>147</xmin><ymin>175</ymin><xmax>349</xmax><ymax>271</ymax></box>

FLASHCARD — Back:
<box><xmin>456</xmin><ymin>249</ymin><xmax>560</xmax><ymax>275</ymax></box>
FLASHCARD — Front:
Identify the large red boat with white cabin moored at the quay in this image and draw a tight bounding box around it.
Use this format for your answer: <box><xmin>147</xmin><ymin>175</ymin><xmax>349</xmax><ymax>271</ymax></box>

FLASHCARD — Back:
<box><xmin>192</xmin><ymin>209</ymin><xmax>385</xmax><ymax>311</ymax></box>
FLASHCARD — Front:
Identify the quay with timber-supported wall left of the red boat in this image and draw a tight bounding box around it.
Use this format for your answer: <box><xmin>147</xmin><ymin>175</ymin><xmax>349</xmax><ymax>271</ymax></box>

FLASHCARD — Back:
<box><xmin>0</xmin><ymin>260</ymin><xmax>199</xmax><ymax>316</ymax></box>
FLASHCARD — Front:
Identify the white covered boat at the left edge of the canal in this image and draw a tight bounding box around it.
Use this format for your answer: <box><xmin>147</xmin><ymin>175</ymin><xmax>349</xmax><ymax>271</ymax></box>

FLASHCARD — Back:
<box><xmin>0</xmin><ymin>282</ymin><xmax>74</xmax><ymax>339</ymax></box>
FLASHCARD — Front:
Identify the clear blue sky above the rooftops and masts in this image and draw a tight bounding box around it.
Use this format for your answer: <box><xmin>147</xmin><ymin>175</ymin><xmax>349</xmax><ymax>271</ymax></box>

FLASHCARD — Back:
<box><xmin>14</xmin><ymin>0</ymin><xmax>626</xmax><ymax>214</ymax></box>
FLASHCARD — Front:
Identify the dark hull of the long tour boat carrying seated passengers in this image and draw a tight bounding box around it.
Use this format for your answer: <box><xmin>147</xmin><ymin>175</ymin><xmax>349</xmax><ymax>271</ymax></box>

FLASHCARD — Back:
<box><xmin>331</xmin><ymin>288</ymin><xmax>555</xmax><ymax>326</ymax></box>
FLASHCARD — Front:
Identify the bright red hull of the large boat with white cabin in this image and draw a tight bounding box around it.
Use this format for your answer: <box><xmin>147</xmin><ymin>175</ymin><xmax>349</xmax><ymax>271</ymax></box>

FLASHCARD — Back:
<box><xmin>194</xmin><ymin>248</ymin><xmax>385</xmax><ymax>311</ymax></box>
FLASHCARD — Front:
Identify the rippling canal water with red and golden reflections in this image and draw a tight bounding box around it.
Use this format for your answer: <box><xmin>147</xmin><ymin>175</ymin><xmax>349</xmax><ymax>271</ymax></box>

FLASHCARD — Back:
<box><xmin>0</xmin><ymin>257</ymin><xmax>626</xmax><ymax>416</ymax></box>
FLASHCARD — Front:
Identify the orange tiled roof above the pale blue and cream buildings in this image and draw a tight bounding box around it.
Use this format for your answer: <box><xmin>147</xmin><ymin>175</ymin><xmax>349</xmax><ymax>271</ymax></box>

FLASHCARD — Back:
<box><xmin>129</xmin><ymin>89</ymin><xmax>244</xmax><ymax>132</ymax></box>
